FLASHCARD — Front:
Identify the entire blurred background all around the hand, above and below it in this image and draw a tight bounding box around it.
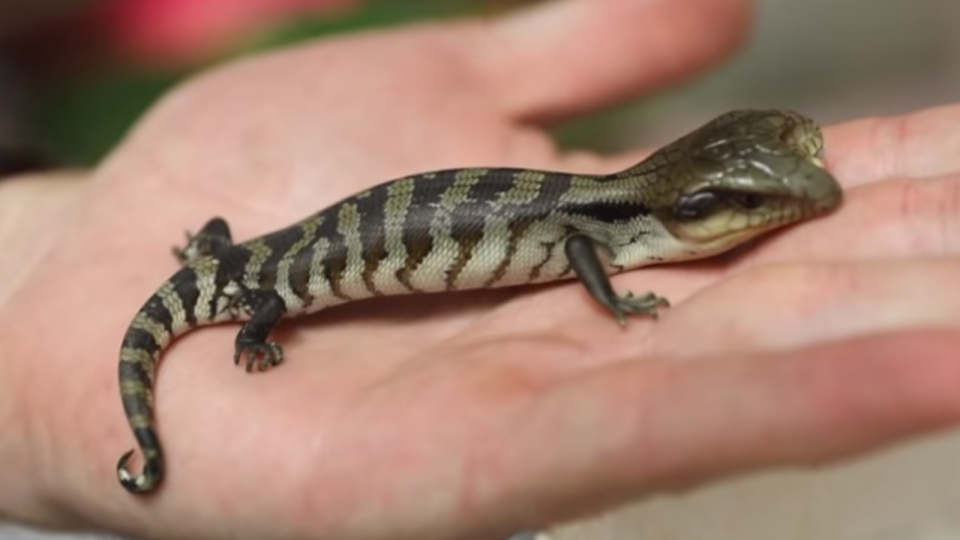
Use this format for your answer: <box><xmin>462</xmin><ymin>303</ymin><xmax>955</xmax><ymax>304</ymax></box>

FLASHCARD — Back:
<box><xmin>0</xmin><ymin>0</ymin><xmax>960</xmax><ymax>540</ymax></box>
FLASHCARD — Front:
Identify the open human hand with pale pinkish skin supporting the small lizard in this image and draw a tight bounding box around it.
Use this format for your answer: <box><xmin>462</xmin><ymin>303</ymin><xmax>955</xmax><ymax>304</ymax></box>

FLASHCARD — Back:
<box><xmin>0</xmin><ymin>0</ymin><xmax>960</xmax><ymax>540</ymax></box>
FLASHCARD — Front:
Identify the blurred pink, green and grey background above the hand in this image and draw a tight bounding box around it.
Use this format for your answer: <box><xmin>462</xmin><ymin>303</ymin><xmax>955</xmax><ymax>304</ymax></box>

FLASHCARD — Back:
<box><xmin>0</xmin><ymin>0</ymin><xmax>960</xmax><ymax>171</ymax></box>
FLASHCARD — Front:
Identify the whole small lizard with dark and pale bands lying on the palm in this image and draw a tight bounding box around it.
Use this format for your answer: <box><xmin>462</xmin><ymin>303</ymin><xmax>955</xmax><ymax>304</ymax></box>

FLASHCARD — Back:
<box><xmin>117</xmin><ymin>109</ymin><xmax>842</xmax><ymax>494</ymax></box>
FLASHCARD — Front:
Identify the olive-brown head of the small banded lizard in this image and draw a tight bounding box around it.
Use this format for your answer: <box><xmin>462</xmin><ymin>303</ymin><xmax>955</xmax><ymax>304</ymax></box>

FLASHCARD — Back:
<box><xmin>657</xmin><ymin>110</ymin><xmax>842</xmax><ymax>256</ymax></box>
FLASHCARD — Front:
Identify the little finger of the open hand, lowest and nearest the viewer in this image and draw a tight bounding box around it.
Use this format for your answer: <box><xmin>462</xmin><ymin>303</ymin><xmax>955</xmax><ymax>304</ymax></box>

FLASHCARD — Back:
<box><xmin>493</xmin><ymin>332</ymin><xmax>960</xmax><ymax>525</ymax></box>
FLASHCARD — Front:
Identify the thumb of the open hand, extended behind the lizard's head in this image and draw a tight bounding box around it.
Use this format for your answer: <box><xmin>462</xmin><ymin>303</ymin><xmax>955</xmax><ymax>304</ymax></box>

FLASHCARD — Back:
<box><xmin>471</xmin><ymin>0</ymin><xmax>752</xmax><ymax>120</ymax></box>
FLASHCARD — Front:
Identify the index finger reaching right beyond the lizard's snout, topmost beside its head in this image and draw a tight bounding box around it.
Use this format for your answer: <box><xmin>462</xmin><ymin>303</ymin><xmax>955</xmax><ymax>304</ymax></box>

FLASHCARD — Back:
<box><xmin>825</xmin><ymin>105</ymin><xmax>960</xmax><ymax>185</ymax></box>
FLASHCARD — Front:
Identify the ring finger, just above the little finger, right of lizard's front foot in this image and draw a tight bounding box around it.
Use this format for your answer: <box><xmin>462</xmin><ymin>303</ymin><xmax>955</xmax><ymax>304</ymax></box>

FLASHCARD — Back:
<box><xmin>651</xmin><ymin>258</ymin><xmax>960</xmax><ymax>358</ymax></box>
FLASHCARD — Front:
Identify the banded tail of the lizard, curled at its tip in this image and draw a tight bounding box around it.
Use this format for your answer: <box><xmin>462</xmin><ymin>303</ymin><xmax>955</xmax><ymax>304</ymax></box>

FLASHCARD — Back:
<box><xmin>117</xmin><ymin>268</ymin><xmax>197</xmax><ymax>494</ymax></box>
